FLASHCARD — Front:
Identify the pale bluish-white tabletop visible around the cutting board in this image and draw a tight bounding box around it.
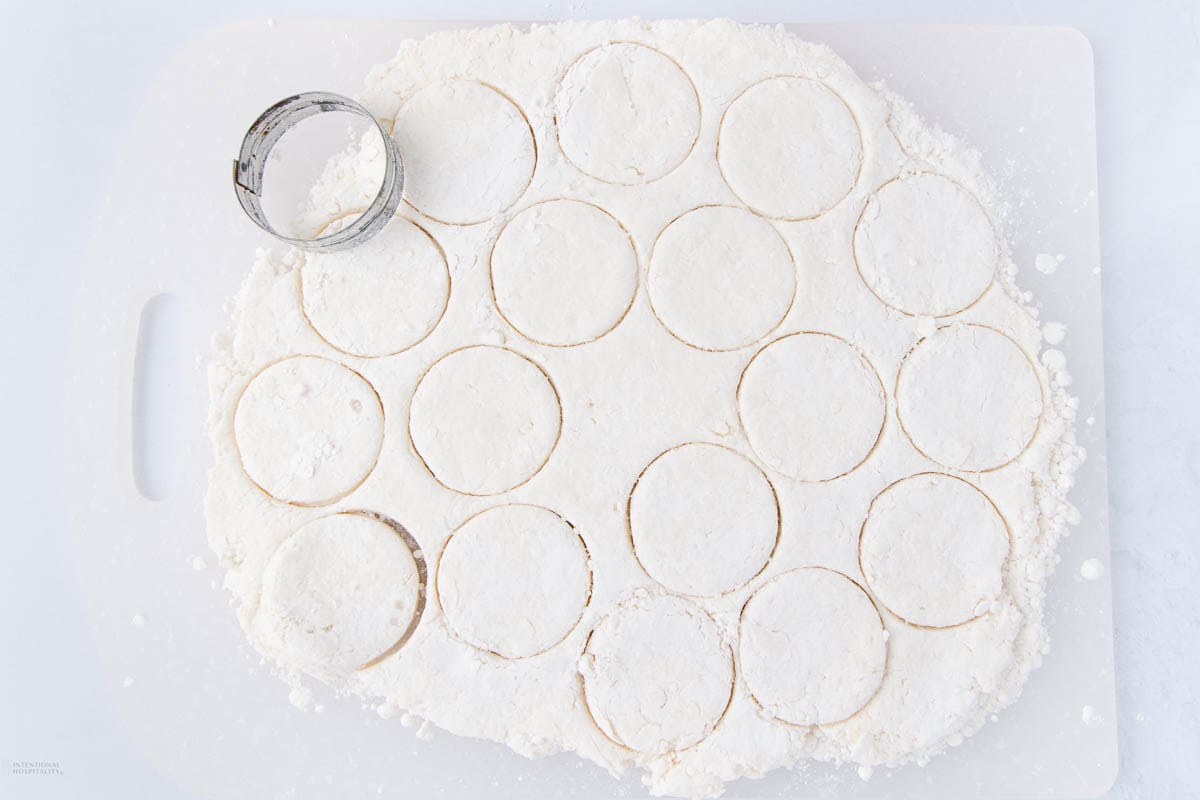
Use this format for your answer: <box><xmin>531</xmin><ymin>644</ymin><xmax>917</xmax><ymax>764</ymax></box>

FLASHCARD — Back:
<box><xmin>0</xmin><ymin>0</ymin><xmax>1200</xmax><ymax>800</ymax></box>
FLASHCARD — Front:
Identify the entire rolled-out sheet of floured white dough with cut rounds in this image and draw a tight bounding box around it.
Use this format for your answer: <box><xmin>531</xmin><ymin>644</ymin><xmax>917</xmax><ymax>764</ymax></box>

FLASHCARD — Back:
<box><xmin>208</xmin><ymin>20</ymin><xmax>1089</xmax><ymax>798</ymax></box>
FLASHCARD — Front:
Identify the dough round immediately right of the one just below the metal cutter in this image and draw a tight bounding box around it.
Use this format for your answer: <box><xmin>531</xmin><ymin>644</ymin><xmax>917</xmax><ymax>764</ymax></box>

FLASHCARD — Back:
<box><xmin>491</xmin><ymin>200</ymin><xmax>637</xmax><ymax>347</ymax></box>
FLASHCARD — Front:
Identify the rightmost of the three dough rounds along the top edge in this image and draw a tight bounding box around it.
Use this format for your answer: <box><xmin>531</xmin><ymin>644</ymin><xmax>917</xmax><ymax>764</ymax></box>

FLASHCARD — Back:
<box><xmin>716</xmin><ymin>76</ymin><xmax>863</xmax><ymax>219</ymax></box>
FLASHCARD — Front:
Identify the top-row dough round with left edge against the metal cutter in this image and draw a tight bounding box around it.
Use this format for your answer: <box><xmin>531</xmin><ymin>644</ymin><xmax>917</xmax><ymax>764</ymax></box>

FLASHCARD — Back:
<box><xmin>392</xmin><ymin>80</ymin><xmax>538</xmax><ymax>225</ymax></box>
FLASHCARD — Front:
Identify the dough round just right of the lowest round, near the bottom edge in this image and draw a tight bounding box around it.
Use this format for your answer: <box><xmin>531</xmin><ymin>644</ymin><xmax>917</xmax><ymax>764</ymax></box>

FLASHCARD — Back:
<box><xmin>738</xmin><ymin>567</ymin><xmax>887</xmax><ymax>726</ymax></box>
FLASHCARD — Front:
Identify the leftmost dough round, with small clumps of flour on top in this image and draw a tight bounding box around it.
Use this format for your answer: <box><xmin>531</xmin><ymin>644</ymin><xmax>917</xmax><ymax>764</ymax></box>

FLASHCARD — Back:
<box><xmin>233</xmin><ymin>355</ymin><xmax>383</xmax><ymax>505</ymax></box>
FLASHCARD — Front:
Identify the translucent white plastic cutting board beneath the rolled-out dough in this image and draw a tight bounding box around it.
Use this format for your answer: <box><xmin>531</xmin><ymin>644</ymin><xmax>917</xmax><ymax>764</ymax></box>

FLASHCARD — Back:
<box><xmin>67</xmin><ymin>20</ymin><xmax>1117</xmax><ymax>800</ymax></box>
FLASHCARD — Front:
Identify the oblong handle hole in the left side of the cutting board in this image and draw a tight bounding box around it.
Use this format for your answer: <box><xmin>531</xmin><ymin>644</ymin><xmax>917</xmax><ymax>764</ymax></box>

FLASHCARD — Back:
<box><xmin>132</xmin><ymin>294</ymin><xmax>184</xmax><ymax>500</ymax></box>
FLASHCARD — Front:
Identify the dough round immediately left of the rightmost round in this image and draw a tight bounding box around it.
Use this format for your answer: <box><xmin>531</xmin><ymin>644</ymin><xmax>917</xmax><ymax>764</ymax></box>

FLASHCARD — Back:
<box><xmin>737</xmin><ymin>332</ymin><xmax>887</xmax><ymax>481</ymax></box>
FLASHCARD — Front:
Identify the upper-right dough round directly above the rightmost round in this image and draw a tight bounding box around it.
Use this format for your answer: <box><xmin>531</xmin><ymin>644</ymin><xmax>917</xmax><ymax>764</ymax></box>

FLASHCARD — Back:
<box><xmin>854</xmin><ymin>175</ymin><xmax>1000</xmax><ymax>317</ymax></box>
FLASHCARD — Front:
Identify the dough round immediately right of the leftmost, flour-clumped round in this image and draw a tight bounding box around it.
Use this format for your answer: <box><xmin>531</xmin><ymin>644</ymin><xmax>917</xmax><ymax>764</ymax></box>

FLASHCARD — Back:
<box><xmin>408</xmin><ymin>345</ymin><xmax>562</xmax><ymax>495</ymax></box>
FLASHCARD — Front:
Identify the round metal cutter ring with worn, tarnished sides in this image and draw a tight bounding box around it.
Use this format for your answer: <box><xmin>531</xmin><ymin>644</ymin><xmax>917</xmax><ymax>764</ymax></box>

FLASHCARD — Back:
<box><xmin>233</xmin><ymin>91</ymin><xmax>404</xmax><ymax>252</ymax></box>
